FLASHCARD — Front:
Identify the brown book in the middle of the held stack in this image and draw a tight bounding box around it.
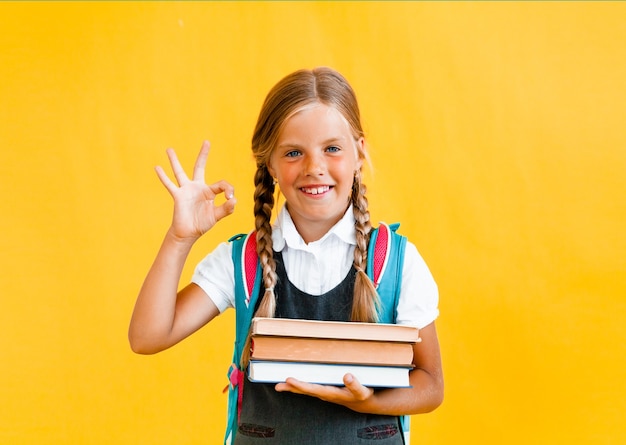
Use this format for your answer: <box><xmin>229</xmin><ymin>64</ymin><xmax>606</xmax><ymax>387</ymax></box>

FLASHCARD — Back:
<box><xmin>251</xmin><ymin>335</ymin><xmax>413</xmax><ymax>366</ymax></box>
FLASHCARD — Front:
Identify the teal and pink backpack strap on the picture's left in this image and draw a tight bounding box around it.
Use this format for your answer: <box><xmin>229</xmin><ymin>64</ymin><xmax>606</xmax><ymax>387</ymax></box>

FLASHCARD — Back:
<box><xmin>224</xmin><ymin>232</ymin><xmax>262</xmax><ymax>444</ymax></box>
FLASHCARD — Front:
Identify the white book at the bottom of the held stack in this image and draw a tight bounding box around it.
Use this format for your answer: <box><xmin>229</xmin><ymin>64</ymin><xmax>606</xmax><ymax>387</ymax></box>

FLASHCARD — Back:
<box><xmin>248</xmin><ymin>361</ymin><xmax>412</xmax><ymax>388</ymax></box>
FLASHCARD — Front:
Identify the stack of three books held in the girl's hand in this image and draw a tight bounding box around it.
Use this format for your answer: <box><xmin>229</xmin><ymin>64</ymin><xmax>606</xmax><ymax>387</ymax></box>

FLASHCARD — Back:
<box><xmin>248</xmin><ymin>318</ymin><xmax>420</xmax><ymax>388</ymax></box>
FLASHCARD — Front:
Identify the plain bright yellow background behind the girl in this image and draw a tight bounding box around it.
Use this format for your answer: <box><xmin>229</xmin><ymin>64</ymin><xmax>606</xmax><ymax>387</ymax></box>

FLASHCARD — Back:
<box><xmin>0</xmin><ymin>2</ymin><xmax>626</xmax><ymax>444</ymax></box>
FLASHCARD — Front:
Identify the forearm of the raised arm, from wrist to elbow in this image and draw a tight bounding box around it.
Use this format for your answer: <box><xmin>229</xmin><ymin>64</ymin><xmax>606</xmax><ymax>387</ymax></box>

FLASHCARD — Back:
<box><xmin>128</xmin><ymin>232</ymin><xmax>192</xmax><ymax>353</ymax></box>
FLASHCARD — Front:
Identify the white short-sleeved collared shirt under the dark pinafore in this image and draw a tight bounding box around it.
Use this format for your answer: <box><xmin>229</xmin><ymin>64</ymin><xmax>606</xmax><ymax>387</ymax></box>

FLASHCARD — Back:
<box><xmin>191</xmin><ymin>207</ymin><xmax>439</xmax><ymax>328</ymax></box>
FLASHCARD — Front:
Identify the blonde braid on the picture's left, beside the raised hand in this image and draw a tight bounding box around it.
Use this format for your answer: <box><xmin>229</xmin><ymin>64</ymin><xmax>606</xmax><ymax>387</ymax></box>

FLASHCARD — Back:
<box><xmin>254</xmin><ymin>165</ymin><xmax>277</xmax><ymax>317</ymax></box>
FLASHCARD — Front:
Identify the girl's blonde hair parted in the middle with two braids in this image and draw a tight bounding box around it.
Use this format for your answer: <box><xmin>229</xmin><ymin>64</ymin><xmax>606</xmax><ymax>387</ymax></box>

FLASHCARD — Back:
<box><xmin>252</xmin><ymin>67</ymin><xmax>380</xmax><ymax>322</ymax></box>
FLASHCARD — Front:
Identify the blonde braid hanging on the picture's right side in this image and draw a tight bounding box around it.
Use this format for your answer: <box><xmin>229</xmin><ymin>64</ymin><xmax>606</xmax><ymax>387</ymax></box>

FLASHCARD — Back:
<box><xmin>351</xmin><ymin>170</ymin><xmax>380</xmax><ymax>322</ymax></box>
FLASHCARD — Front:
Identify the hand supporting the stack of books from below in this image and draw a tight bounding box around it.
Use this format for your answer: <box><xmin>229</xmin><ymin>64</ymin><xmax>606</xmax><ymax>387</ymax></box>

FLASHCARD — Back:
<box><xmin>275</xmin><ymin>374</ymin><xmax>374</xmax><ymax>411</ymax></box>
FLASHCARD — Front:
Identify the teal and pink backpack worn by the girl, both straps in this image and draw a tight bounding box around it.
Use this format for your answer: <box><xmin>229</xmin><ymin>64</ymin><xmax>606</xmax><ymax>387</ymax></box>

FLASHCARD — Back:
<box><xmin>224</xmin><ymin>223</ymin><xmax>410</xmax><ymax>445</ymax></box>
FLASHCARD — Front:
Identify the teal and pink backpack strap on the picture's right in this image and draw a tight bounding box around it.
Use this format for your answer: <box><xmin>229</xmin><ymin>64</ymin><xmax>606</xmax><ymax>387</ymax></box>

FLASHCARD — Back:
<box><xmin>367</xmin><ymin>223</ymin><xmax>411</xmax><ymax>444</ymax></box>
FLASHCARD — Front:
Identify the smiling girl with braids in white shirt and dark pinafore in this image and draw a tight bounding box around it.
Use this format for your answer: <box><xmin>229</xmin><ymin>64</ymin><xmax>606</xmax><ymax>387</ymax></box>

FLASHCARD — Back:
<box><xmin>129</xmin><ymin>68</ymin><xmax>443</xmax><ymax>445</ymax></box>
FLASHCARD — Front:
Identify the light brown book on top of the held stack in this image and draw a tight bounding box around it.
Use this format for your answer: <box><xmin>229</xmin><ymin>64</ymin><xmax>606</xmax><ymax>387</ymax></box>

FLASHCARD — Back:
<box><xmin>251</xmin><ymin>317</ymin><xmax>420</xmax><ymax>343</ymax></box>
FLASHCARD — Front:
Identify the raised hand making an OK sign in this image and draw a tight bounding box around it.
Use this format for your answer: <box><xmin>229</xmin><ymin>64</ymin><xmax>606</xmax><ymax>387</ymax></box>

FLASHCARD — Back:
<box><xmin>155</xmin><ymin>141</ymin><xmax>237</xmax><ymax>242</ymax></box>
